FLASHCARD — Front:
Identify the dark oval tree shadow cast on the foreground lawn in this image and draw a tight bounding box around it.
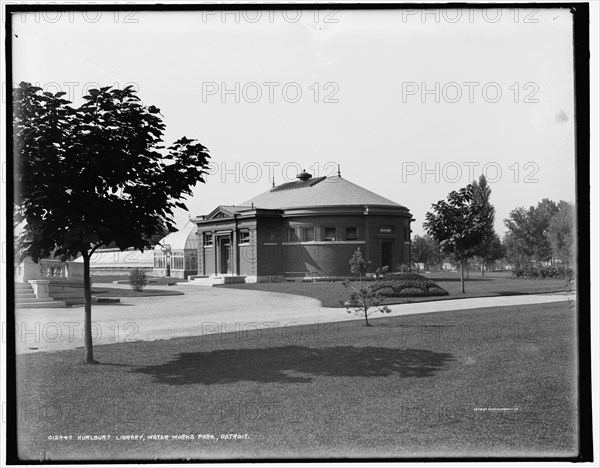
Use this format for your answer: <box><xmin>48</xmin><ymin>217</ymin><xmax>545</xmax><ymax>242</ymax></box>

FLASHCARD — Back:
<box><xmin>135</xmin><ymin>346</ymin><xmax>454</xmax><ymax>385</ymax></box>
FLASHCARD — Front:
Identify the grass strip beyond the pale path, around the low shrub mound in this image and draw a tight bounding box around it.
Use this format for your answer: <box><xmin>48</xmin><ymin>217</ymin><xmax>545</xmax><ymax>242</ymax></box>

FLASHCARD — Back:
<box><xmin>216</xmin><ymin>272</ymin><xmax>568</xmax><ymax>307</ymax></box>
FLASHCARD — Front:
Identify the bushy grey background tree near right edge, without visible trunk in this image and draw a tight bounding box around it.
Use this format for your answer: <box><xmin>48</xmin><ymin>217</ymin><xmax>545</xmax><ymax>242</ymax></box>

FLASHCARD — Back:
<box><xmin>504</xmin><ymin>198</ymin><xmax>558</xmax><ymax>266</ymax></box>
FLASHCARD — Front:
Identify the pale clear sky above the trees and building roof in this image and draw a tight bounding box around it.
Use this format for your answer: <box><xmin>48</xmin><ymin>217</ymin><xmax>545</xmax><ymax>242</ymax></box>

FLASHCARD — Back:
<box><xmin>9</xmin><ymin>9</ymin><xmax>575</xmax><ymax>235</ymax></box>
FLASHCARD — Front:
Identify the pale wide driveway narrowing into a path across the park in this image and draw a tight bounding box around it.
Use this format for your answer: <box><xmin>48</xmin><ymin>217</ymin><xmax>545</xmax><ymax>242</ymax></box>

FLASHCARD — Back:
<box><xmin>15</xmin><ymin>285</ymin><xmax>574</xmax><ymax>354</ymax></box>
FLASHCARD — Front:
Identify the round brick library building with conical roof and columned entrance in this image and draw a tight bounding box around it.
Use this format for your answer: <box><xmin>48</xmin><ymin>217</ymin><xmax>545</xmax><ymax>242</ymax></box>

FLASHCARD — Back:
<box><xmin>192</xmin><ymin>172</ymin><xmax>412</xmax><ymax>282</ymax></box>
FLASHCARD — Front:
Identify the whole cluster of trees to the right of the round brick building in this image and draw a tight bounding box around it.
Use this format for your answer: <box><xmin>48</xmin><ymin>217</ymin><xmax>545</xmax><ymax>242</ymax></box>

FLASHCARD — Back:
<box><xmin>411</xmin><ymin>175</ymin><xmax>575</xmax><ymax>292</ymax></box>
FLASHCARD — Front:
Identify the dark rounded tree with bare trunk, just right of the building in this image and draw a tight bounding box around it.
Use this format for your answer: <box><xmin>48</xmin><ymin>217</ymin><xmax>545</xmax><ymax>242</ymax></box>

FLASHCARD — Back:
<box><xmin>423</xmin><ymin>184</ymin><xmax>489</xmax><ymax>293</ymax></box>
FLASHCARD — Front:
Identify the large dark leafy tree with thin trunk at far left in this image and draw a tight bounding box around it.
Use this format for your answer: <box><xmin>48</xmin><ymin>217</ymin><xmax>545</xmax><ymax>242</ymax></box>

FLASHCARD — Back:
<box><xmin>13</xmin><ymin>82</ymin><xmax>209</xmax><ymax>364</ymax></box>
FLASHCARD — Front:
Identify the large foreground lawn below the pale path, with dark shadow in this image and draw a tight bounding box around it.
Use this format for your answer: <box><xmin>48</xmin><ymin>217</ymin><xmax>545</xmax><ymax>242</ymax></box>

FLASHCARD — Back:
<box><xmin>17</xmin><ymin>303</ymin><xmax>577</xmax><ymax>460</ymax></box>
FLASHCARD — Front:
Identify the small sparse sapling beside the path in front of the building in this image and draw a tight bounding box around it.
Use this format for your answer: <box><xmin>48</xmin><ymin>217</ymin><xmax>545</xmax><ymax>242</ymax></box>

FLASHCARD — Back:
<box><xmin>340</xmin><ymin>247</ymin><xmax>391</xmax><ymax>327</ymax></box>
